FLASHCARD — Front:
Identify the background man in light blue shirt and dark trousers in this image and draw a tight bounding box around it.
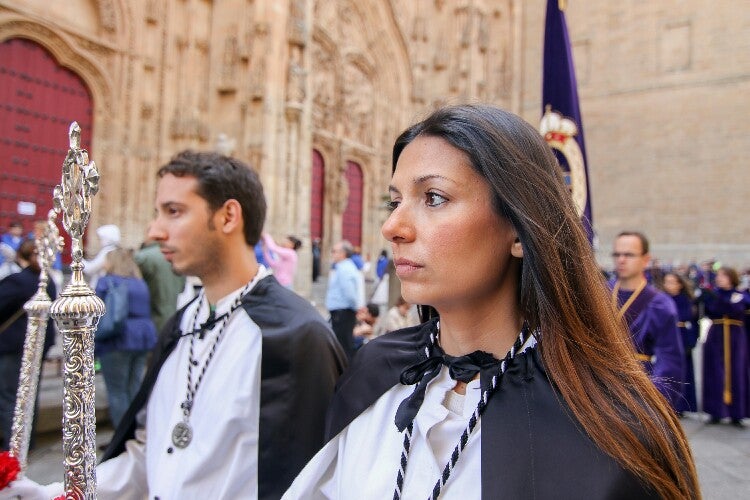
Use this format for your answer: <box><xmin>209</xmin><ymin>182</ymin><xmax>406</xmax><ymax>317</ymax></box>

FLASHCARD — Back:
<box><xmin>326</xmin><ymin>240</ymin><xmax>364</xmax><ymax>359</ymax></box>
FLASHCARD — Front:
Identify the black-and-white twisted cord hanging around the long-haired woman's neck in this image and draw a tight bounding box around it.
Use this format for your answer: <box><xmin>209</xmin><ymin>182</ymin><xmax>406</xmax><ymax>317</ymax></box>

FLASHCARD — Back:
<box><xmin>393</xmin><ymin>322</ymin><xmax>527</xmax><ymax>500</ymax></box>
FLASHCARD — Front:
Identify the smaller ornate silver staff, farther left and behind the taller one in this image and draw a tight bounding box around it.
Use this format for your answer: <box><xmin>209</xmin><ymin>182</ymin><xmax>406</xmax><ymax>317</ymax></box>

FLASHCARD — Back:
<box><xmin>10</xmin><ymin>210</ymin><xmax>63</xmax><ymax>474</ymax></box>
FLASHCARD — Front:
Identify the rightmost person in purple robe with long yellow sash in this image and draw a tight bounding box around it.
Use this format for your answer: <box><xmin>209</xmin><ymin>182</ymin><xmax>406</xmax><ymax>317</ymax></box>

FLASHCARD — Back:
<box><xmin>703</xmin><ymin>267</ymin><xmax>750</xmax><ymax>427</ymax></box>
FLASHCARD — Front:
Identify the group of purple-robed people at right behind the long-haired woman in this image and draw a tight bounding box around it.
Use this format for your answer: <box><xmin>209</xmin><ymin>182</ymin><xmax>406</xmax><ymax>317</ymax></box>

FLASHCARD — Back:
<box><xmin>610</xmin><ymin>240</ymin><xmax>750</xmax><ymax>428</ymax></box>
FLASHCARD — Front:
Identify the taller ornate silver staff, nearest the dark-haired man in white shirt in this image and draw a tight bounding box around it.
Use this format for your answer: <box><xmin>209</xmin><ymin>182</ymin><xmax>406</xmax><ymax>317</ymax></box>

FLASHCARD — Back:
<box><xmin>50</xmin><ymin>122</ymin><xmax>104</xmax><ymax>499</ymax></box>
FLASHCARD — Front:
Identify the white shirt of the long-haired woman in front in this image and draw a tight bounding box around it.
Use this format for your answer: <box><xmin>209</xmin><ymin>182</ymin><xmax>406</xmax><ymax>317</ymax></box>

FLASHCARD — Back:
<box><xmin>283</xmin><ymin>367</ymin><xmax>481</xmax><ymax>500</ymax></box>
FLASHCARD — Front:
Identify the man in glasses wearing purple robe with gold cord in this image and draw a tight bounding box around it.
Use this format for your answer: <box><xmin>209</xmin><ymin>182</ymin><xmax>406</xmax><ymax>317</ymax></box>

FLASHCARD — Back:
<box><xmin>612</xmin><ymin>231</ymin><xmax>685</xmax><ymax>406</ymax></box>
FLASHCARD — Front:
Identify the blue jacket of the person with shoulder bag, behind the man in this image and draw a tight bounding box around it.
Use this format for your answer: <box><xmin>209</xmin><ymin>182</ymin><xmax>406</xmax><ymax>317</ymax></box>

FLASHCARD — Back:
<box><xmin>96</xmin><ymin>274</ymin><xmax>156</xmax><ymax>355</ymax></box>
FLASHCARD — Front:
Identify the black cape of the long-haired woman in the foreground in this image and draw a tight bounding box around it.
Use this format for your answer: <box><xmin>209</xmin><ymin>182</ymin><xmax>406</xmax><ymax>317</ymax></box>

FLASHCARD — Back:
<box><xmin>326</xmin><ymin>320</ymin><xmax>658</xmax><ymax>500</ymax></box>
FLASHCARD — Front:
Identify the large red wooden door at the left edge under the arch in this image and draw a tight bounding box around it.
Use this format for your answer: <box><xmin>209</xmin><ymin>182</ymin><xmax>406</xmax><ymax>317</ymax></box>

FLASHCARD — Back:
<box><xmin>0</xmin><ymin>38</ymin><xmax>92</xmax><ymax>262</ymax></box>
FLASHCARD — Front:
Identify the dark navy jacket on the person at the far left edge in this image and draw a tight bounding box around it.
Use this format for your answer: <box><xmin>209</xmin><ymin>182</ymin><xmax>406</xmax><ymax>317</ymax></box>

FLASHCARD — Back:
<box><xmin>0</xmin><ymin>267</ymin><xmax>57</xmax><ymax>357</ymax></box>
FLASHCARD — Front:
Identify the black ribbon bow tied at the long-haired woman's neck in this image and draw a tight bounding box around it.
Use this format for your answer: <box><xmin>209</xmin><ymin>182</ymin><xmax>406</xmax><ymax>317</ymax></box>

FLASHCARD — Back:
<box><xmin>396</xmin><ymin>344</ymin><xmax>500</xmax><ymax>432</ymax></box>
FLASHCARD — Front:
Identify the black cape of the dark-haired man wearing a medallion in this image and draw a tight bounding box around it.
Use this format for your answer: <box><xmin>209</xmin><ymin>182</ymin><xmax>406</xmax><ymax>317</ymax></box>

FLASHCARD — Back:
<box><xmin>102</xmin><ymin>276</ymin><xmax>346</xmax><ymax>499</ymax></box>
